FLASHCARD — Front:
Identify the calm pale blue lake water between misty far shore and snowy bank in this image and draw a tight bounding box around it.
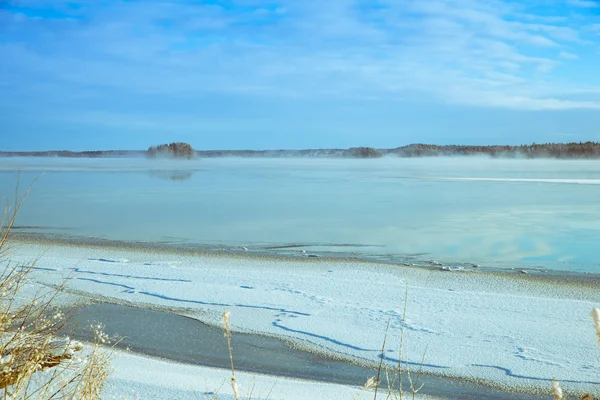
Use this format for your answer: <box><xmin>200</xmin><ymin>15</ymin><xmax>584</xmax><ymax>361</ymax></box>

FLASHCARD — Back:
<box><xmin>0</xmin><ymin>158</ymin><xmax>600</xmax><ymax>273</ymax></box>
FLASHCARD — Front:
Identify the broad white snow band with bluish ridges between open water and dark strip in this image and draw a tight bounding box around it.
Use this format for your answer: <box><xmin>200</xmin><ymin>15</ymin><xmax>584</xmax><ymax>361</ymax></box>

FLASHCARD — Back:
<box><xmin>12</xmin><ymin>244</ymin><xmax>600</xmax><ymax>398</ymax></box>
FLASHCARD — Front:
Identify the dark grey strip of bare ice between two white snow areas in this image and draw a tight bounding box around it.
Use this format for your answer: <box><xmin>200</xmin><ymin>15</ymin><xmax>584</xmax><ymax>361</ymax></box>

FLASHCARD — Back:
<box><xmin>64</xmin><ymin>303</ymin><xmax>547</xmax><ymax>400</ymax></box>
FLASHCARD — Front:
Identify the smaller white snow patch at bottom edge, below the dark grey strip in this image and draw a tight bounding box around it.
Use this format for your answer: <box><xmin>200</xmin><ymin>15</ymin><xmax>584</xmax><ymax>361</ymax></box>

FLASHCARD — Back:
<box><xmin>103</xmin><ymin>351</ymin><xmax>434</xmax><ymax>400</ymax></box>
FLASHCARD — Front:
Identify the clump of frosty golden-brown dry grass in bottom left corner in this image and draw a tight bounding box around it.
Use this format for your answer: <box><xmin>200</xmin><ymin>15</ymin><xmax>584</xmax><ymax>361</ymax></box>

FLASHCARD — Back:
<box><xmin>0</xmin><ymin>180</ymin><xmax>109</xmax><ymax>400</ymax></box>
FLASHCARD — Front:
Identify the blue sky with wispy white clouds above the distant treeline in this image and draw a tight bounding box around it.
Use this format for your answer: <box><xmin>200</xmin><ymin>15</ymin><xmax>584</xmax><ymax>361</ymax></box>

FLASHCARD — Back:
<box><xmin>0</xmin><ymin>0</ymin><xmax>600</xmax><ymax>150</ymax></box>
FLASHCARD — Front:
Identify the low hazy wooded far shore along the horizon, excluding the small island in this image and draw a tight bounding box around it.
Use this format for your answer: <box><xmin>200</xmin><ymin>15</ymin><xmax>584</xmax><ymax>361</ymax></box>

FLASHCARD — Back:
<box><xmin>0</xmin><ymin>142</ymin><xmax>600</xmax><ymax>159</ymax></box>
